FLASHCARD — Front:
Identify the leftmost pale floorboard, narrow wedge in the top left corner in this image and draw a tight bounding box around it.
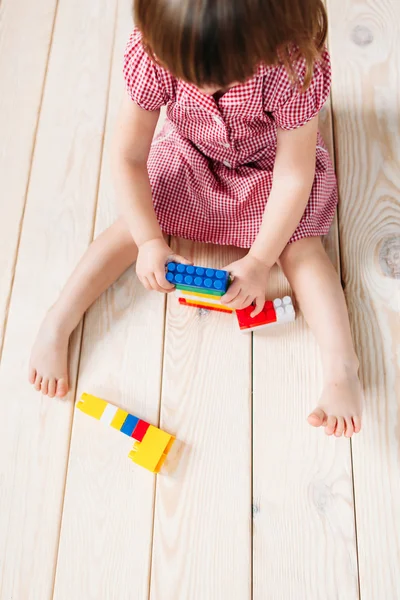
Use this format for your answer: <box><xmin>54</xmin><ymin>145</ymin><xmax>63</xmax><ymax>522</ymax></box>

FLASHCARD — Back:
<box><xmin>0</xmin><ymin>0</ymin><xmax>57</xmax><ymax>354</ymax></box>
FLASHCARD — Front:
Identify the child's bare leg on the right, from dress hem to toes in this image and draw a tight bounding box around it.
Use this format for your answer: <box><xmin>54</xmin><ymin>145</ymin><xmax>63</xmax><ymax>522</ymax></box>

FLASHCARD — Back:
<box><xmin>280</xmin><ymin>238</ymin><xmax>363</xmax><ymax>437</ymax></box>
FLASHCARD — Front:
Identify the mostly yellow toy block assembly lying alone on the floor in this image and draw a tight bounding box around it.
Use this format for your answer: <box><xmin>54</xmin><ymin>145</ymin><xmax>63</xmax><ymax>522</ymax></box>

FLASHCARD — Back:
<box><xmin>76</xmin><ymin>394</ymin><xmax>175</xmax><ymax>473</ymax></box>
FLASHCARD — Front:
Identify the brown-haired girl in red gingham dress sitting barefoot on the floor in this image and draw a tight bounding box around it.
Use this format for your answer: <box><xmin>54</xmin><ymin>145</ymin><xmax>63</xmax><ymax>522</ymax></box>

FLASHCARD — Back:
<box><xmin>29</xmin><ymin>0</ymin><xmax>362</xmax><ymax>437</ymax></box>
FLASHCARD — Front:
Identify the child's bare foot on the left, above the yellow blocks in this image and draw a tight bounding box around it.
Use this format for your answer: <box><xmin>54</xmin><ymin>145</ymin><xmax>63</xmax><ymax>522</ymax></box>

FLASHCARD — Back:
<box><xmin>29</xmin><ymin>310</ymin><xmax>71</xmax><ymax>398</ymax></box>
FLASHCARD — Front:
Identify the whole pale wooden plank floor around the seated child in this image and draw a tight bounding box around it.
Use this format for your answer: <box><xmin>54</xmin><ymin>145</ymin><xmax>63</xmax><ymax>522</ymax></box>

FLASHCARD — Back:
<box><xmin>0</xmin><ymin>0</ymin><xmax>400</xmax><ymax>600</ymax></box>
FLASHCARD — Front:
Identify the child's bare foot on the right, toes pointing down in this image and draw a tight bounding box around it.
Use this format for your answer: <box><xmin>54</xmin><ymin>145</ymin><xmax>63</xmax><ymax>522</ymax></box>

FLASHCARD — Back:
<box><xmin>308</xmin><ymin>369</ymin><xmax>364</xmax><ymax>437</ymax></box>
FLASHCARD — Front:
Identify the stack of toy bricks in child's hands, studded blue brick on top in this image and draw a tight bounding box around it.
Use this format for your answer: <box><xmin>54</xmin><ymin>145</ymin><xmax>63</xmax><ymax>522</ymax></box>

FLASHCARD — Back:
<box><xmin>166</xmin><ymin>262</ymin><xmax>233</xmax><ymax>313</ymax></box>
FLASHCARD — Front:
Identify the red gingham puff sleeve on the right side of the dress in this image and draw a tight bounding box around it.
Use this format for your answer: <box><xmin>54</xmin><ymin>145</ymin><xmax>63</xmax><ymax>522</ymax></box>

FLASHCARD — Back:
<box><xmin>272</xmin><ymin>50</ymin><xmax>331</xmax><ymax>129</ymax></box>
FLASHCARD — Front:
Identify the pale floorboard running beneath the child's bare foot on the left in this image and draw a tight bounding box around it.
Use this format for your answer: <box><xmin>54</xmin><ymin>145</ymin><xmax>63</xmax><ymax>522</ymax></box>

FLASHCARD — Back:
<box><xmin>0</xmin><ymin>0</ymin><xmax>115</xmax><ymax>600</ymax></box>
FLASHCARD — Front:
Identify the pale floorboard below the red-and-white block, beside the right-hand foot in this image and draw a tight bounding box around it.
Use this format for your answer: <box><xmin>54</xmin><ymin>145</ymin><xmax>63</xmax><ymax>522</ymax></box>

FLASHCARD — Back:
<box><xmin>253</xmin><ymin>78</ymin><xmax>358</xmax><ymax>600</ymax></box>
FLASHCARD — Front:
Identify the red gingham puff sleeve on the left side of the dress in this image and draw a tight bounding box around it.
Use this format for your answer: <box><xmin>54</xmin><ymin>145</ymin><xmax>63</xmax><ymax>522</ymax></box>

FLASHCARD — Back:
<box><xmin>124</xmin><ymin>28</ymin><xmax>168</xmax><ymax>110</ymax></box>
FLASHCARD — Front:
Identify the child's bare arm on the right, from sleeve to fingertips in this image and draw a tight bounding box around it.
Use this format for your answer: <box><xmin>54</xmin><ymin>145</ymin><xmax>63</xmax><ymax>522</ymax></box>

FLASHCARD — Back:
<box><xmin>221</xmin><ymin>117</ymin><xmax>318</xmax><ymax>316</ymax></box>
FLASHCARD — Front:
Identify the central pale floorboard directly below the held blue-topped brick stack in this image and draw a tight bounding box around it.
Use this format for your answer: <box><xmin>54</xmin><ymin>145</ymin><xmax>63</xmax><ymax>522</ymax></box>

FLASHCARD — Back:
<box><xmin>150</xmin><ymin>240</ymin><xmax>251</xmax><ymax>600</ymax></box>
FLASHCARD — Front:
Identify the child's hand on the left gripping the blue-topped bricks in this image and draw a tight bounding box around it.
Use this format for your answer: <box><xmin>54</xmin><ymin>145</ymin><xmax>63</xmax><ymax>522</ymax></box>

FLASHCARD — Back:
<box><xmin>136</xmin><ymin>238</ymin><xmax>191</xmax><ymax>293</ymax></box>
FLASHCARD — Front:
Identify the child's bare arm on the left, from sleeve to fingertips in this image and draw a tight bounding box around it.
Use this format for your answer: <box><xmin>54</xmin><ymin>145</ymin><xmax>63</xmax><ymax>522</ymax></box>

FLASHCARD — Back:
<box><xmin>112</xmin><ymin>96</ymin><xmax>189</xmax><ymax>292</ymax></box>
